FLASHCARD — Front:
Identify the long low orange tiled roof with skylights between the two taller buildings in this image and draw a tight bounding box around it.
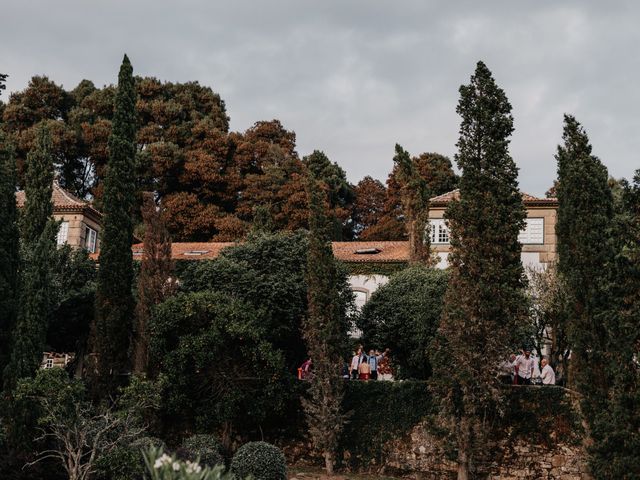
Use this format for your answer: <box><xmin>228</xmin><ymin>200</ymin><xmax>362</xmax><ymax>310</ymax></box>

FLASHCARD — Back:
<box><xmin>125</xmin><ymin>242</ymin><xmax>409</xmax><ymax>262</ymax></box>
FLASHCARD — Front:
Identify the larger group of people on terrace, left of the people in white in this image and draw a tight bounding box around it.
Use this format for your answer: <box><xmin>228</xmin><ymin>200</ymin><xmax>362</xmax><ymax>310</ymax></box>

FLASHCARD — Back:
<box><xmin>298</xmin><ymin>345</ymin><xmax>393</xmax><ymax>380</ymax></box>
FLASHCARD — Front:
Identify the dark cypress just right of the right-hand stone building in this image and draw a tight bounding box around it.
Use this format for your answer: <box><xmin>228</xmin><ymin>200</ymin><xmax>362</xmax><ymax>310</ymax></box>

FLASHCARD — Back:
<box><xmin>556</xmin><ymin>115</ymin><xmax>613</xmax><ymax>419</ymax></box>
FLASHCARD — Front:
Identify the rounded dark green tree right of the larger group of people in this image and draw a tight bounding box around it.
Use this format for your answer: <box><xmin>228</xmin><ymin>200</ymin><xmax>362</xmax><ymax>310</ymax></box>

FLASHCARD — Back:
<box><xmin>357</xmin><ymin>265</ymin><xmax>448</xmax><ymax>379</ymax></box>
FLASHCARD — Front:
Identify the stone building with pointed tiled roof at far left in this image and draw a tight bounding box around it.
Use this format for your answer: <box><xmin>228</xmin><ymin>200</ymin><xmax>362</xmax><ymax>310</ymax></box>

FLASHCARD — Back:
<box><xmin>16</xmin><ymin>181</ymin><xmax>102</xmax><ymax>253</ymax></box>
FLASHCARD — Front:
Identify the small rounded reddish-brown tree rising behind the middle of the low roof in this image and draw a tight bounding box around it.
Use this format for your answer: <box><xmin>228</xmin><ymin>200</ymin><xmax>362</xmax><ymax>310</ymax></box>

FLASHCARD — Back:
<box><xmin>352</xmin><ymin>175</ymin><xmax>387</xmax><ymax>240</ymax></box>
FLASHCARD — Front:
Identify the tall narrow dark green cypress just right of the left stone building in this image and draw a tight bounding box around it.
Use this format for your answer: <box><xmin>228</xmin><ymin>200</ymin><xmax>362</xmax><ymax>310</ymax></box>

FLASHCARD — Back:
<box><xmin>93</xmin><ymin>55</ymin><xmax>136</xmax><ymax>388</ymax></box>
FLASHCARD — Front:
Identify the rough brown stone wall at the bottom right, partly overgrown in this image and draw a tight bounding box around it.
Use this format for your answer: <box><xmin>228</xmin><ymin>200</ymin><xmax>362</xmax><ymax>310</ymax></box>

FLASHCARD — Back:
<box><xmin>385</xmin><ymin>425</ymin><xmax>590</xmax><ymax>480</ymax></box>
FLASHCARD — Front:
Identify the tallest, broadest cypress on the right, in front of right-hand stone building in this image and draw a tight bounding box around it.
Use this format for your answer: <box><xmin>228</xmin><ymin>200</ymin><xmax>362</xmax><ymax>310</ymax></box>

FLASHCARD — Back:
<box><xmin>432</xmin><ymin>62</ymin><xmax>527</xmax><ymax>480</ymax></box>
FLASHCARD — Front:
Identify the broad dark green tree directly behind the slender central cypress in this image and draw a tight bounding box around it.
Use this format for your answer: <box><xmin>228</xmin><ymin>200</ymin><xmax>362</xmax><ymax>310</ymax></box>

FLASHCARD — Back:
<box><xmin>180</xmin><ymin>231</ymin><xmax>352</xmax><ymax>372</ymax></box>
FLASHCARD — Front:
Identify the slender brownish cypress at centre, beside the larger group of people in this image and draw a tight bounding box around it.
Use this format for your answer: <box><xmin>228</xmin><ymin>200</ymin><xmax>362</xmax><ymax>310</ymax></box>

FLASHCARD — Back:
<box><xmin>303</xmin><ymin>175</ymin><xmax>346</xmax><ymax>475</ymax></box>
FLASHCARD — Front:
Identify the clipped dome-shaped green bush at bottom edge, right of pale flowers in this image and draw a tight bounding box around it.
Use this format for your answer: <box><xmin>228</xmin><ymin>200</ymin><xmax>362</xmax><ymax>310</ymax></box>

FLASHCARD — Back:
<box><xmin>231</xmin><ymin>442</ymin><xmax>287</xmax><ymax>480</ymax></box>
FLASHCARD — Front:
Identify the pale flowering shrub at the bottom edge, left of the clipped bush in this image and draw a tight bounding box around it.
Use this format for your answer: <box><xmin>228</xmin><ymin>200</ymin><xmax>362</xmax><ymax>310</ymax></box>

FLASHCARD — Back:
<box><xmin>145</xmin><ymin>448</ymin><xmax>233</xmax><ymax>480</ymax></box>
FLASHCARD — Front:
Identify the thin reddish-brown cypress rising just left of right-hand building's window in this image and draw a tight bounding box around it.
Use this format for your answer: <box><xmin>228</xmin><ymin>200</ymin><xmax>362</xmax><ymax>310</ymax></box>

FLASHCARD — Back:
<box><xmin>393</xmin><ymin>144</ymin><xmax>432</xmax><ymax>264</ymax></box>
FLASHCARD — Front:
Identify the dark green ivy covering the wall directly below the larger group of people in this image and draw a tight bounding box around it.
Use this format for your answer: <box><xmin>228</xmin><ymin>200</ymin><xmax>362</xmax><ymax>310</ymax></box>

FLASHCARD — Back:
<box><xmin>339</xmin><ymin>381</ymin><xmax>435</xmax><ymax>466</ymax></box>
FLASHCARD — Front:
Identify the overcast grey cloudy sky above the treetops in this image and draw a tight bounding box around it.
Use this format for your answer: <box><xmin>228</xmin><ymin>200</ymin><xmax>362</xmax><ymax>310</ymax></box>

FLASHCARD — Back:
<box><xmin>0</xmin><ymin>0</ymin><xmax>640</xmax><ymax>194</ymax></box>
